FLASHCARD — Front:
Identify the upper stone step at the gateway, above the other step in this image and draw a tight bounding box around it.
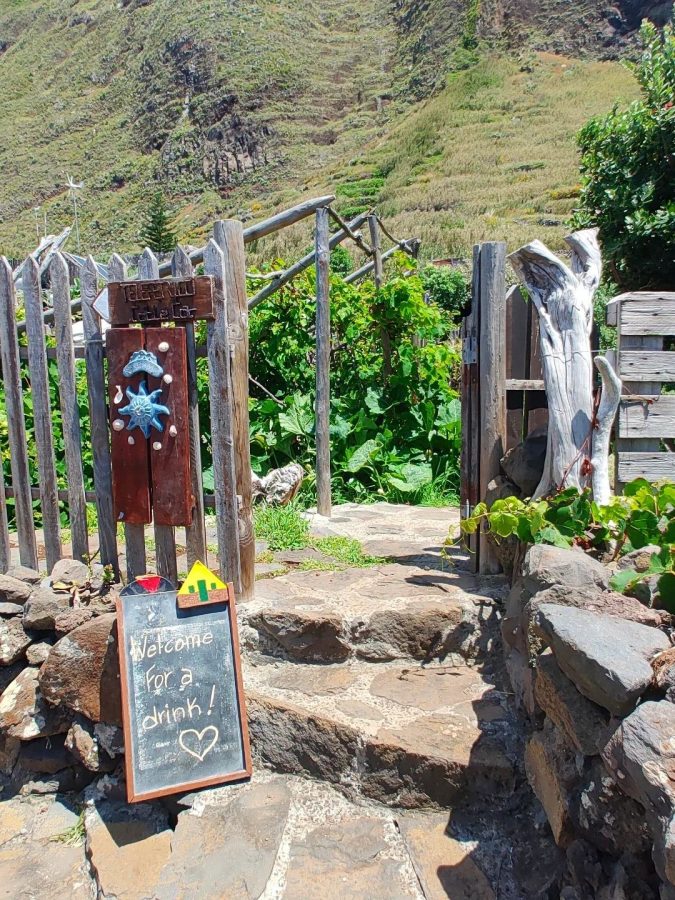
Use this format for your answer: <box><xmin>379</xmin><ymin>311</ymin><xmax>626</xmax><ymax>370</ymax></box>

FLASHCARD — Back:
<box><xmin>238</xmin><ymin>553</ymin><xmax>506</xmax><ymax>663</ymax></box>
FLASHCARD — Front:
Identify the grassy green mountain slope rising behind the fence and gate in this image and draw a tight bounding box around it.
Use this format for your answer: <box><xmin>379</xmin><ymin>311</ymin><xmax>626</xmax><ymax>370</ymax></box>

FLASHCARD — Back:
<box><xmin>0</xmin><ymin>0</ymin><xmax>668</xmax><ymax>256</ymax></box>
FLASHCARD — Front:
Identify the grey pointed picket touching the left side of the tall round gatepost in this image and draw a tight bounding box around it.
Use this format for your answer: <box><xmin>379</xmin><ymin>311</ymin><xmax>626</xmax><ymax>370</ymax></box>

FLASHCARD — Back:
<box><xmin>204</xmin><ymin>238</ymin><xmax>241</xmax><ymax>588</ymax></box>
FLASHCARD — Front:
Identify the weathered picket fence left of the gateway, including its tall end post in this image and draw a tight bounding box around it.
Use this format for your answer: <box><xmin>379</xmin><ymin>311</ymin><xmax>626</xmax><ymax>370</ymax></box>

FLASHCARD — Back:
<box><xmin>0</xmin><ymin>221</ymin><xmax>255</xmax><ymax>596</ymax></box>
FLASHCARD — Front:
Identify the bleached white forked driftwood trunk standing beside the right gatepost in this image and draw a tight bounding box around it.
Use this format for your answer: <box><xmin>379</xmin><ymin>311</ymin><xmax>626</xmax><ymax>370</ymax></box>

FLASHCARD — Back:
<box><xmin>509</xmin><ymin>229</ymin><xmax>621</xmax><ymax>503</ymax></box>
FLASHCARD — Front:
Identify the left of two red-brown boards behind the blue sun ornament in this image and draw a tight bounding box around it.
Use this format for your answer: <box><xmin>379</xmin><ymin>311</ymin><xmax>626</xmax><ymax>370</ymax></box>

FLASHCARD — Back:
<box><xmin>106</xmin><ymin>328</ymin><xmax>152</xmax><ymax>525</ymax></box>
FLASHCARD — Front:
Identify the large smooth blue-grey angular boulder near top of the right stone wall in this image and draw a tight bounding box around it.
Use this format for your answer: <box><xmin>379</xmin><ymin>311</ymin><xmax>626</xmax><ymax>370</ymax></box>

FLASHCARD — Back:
<box><xmin>534</xmin><ymin>603</ymin><xmax>670</xmax><ymax>716</ymax></box>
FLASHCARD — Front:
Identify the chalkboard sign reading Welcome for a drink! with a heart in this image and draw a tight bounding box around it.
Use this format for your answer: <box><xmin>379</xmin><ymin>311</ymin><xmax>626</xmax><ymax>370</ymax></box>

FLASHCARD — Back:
<box><xmin>117</xmin><ymin>591</ymin><xmax>251</xmax><ymax>803</ymax></box>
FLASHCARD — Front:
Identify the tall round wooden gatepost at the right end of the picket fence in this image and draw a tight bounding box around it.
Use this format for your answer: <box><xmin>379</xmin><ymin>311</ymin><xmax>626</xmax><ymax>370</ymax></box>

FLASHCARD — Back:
<box><xmin>214</xmin><ymin>219</ymin><xmax>255</xmax><ymax>601</ymax></box>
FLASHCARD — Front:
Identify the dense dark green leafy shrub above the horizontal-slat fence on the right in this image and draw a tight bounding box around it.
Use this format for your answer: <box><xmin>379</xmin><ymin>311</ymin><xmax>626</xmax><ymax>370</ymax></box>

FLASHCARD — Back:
<box><xmin>574</xmin><ymin>22</ymin><xmax>675</xmax><ymax>289</ymax></box>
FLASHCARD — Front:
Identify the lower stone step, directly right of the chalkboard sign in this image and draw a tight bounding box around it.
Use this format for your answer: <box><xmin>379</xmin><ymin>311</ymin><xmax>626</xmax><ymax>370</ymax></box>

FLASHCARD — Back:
<box><xmin>244</xmin><ymin>657</ymin><xmax>518</xmax><ymax>808</ymax></box>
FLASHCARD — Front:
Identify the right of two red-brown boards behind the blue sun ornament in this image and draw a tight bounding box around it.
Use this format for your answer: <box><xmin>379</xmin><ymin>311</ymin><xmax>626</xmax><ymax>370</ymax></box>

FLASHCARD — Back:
<box><xmin>145</xmin><ymin>328</ymin><xmax>194</xmax><ymax>525</ymax></box>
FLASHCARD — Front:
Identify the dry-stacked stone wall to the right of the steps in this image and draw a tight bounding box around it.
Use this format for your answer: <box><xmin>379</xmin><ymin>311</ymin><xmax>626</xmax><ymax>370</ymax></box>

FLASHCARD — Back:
<box><xmin>502</xmin><ymin>546</ymin><xmax>675</xmax><ymax>900</ymax></box>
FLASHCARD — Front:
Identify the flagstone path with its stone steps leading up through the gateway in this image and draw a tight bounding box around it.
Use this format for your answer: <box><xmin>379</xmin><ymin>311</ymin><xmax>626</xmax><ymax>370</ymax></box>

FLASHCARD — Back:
<box><xmin>0</xmin><ymin>504</ymin><xmax>558</xmax><ymax>900</ymax></box>
